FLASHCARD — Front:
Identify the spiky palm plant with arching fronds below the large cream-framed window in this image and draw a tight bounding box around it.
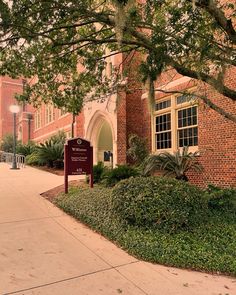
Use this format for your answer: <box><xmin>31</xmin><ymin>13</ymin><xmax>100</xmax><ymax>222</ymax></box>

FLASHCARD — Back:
<box><xmin>143</xmin><ymin>146</ymin><xmax>203</xmax><ymax>181</ymax></box>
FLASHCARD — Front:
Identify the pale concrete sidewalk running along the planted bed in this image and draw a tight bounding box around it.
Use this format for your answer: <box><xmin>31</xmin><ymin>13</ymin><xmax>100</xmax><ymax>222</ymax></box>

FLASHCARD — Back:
<box><xmin>0</xmin><ymin>163</ymin><xmax>236</xmax><ymax>295</ymax></box>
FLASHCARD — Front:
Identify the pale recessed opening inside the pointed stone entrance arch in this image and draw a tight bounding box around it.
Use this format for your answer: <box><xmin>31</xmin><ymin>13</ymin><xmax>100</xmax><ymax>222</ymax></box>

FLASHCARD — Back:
<box><xmin>97</xmin><ymin>121</ymin><xmax>113</xmax><ymax>166</ymax></box>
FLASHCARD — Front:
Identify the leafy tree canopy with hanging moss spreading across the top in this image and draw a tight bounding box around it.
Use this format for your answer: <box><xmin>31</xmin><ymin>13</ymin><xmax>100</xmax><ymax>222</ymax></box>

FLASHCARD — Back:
<box><xmin>0</xmin><ymin>0</ymin><xmax>236</xmax><ymax>121</ymax></box>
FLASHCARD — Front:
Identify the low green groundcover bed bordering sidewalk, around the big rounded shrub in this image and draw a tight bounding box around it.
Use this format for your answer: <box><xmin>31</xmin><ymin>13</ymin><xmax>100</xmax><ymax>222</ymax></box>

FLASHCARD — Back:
<box><xmin>55</xmin><ymin>186</ymin><xmax>236</xmax><ymax>276</ymax></box>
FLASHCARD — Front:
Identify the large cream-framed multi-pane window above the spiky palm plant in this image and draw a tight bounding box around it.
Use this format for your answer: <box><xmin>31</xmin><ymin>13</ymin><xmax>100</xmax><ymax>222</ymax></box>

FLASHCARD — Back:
<box><xmin>154</xmin><ymin>95</ymin><xmax>198</xmax><ymax>151</ymax></box>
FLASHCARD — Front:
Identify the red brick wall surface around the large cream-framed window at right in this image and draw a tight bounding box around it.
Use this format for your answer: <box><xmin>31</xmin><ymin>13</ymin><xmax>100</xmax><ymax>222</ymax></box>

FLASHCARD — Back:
<box><xmin>148</xmin><ymin>69</ymin><xmax>236</xmax><ymax>187</ymax></box>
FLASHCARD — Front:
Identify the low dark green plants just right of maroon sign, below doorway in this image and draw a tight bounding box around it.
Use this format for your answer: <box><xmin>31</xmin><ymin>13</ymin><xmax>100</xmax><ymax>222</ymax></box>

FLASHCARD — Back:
<box><xmin>102</xmin><ymin>165</ymin><xmax>139</xmax><ymax>187</ymax></box>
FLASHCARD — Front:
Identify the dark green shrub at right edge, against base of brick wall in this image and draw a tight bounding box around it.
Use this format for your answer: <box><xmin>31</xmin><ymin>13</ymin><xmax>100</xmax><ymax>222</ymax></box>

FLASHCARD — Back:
<box><xmin>206</xmin><ymin>185</ymin><xmax>236</xmax><ymax>212</ymax></box>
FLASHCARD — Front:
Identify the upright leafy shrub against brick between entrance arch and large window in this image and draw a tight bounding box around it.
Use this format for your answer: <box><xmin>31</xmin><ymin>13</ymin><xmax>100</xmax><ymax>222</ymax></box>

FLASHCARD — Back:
<box><xmin>127</xmin><ymin>134</ymin><xmax>148</xmax><ymax>165</ymax></box>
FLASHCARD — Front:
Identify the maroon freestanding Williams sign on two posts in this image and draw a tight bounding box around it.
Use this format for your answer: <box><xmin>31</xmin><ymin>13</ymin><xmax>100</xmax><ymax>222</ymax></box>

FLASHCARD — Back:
<box><xmin>64</xmin><ymin>138</ymin><xmax>93</xmax><ymax>194</ymax></box>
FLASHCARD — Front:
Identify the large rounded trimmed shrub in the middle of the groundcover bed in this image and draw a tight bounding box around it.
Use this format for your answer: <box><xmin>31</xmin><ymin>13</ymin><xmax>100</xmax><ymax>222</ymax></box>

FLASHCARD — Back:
<box><xmin>112</xmin><ymin>177</ymin><xmax>207</xmax><ymax>231</ymax></box>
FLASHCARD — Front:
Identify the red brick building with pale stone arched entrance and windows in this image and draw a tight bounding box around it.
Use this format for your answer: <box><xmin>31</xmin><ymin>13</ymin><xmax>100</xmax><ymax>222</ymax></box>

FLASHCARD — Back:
<box><xmin>0</xmin><ymin>56</ymin><xmax>236</xmax><ymax>187</ymax></box>
